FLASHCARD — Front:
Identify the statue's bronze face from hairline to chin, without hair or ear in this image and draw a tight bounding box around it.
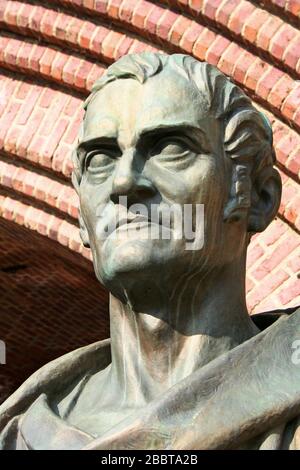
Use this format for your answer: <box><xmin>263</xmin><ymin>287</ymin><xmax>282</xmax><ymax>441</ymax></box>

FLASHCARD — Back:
<box><xmin>79</xmin><ymin>71</ymin><xmax>246</xmax><ymax>295</ymax></box>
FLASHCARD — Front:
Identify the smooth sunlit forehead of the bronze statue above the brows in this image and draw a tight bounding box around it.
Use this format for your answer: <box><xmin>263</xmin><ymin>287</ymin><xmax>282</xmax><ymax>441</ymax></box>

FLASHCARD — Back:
<box><xmin>84</xmin><ymin>72</ymin><xmax>211</xmax><ymax>137</ymax></box>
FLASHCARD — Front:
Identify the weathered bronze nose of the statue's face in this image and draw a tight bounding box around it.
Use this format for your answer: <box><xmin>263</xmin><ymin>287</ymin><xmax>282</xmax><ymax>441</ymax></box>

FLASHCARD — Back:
<box><xmin>110</xmin><ymin>151</ymin><xmax>156</xmax><ymax>204</ymax></box>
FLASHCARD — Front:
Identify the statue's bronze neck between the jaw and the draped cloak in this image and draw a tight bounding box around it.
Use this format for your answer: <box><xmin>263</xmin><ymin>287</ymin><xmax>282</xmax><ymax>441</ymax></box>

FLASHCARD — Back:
<box><xmin>110</xmin><ymin>260</ymin><xmax>259</xmax><ymax>403</ymax></box>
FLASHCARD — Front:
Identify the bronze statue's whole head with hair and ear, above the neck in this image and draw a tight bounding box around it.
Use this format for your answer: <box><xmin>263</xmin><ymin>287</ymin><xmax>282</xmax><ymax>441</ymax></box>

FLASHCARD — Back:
<box><xmin>73</xmin><ymin>53</ymin><xmax>281</xmax><ymax>297</ymax></box>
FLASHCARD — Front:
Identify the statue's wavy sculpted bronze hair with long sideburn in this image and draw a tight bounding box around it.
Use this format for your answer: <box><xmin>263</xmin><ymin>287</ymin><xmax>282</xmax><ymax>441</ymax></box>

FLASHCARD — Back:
<box><xmin>72</xmin><ymin>52</ymin><xmax>275</xmax><ymax>230</ymax></box>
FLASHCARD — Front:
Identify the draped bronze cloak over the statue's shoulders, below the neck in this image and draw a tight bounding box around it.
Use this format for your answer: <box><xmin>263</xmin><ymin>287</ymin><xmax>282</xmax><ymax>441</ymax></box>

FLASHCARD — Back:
<box><xmin>0</xmin><ymin>309</ymin><xmax>300</xmax><ymax>450</ymax></box>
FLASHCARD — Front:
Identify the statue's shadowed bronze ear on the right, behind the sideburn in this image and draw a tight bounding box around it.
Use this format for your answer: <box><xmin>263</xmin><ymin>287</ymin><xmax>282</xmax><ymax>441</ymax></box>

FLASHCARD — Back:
<box><xmin>248</xmin><ymin>167</ymin><xmax>282</xmax><ymax>232</ymax></box>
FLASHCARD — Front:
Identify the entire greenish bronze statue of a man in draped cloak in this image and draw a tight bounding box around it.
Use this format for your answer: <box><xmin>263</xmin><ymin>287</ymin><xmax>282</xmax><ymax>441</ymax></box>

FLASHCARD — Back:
<box><xmin>0</xmin><ymin>53</ymin><xmax>300</xmax><ymax>449</ymax></box>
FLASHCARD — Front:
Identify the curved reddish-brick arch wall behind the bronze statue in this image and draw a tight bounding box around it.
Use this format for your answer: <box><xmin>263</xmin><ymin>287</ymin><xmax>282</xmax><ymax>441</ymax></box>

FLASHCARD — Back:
<box><xmin>0</xmin><ymin>0</ymin><xmax>300</xmax><ymax>400</ymax></box>
